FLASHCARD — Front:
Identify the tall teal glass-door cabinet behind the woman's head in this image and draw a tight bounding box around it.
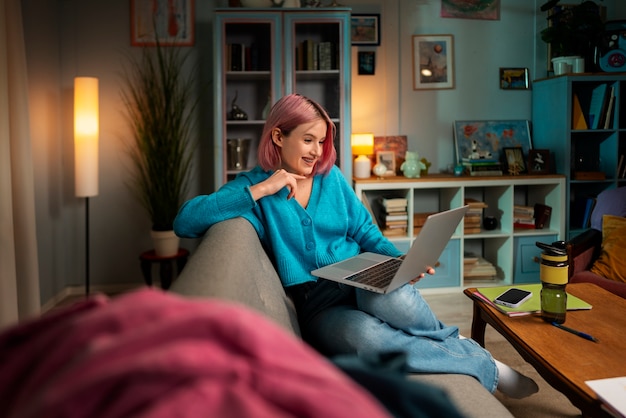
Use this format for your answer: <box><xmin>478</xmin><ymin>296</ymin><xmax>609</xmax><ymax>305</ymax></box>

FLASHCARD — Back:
<box><xmin>213</xmin><ymin>7</ymin><xmax>352</xmax><ymax>188</ymax></box>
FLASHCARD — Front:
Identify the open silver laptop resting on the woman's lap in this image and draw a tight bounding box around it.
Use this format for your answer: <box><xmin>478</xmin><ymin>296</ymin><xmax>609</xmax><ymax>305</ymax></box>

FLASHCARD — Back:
<box><xmin>311</xmin><ymin>206</ymin><xmax>469</xmax><ymax>293</ymax></box>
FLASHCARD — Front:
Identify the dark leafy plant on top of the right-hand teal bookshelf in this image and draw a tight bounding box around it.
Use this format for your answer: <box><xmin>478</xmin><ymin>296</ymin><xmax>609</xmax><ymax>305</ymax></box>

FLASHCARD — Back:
<box><xmin>541</xmin><ymin>0</ymin><xmax>604</xmax><ymax>68</ymax></box>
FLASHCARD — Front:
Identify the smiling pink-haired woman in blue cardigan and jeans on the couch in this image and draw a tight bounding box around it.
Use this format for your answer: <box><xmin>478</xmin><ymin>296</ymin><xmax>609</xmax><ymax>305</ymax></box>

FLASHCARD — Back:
<box><xmin>174</xmin><ymin>94</ymin><xmax>537</xmax><ymax>397</ymax></box>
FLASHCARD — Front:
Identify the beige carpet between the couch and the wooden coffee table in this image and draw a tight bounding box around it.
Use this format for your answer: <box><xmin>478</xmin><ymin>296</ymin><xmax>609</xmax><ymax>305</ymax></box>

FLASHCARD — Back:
<box><xmin>485</xmin><ymin>326</ymin><xmax>582</xmax><ymax>418</ymax></box>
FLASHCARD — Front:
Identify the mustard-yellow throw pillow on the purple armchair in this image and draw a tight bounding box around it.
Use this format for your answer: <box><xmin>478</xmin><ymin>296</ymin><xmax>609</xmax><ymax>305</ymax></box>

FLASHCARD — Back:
<box><xmin>591</xmin><ymin>215</ymin><xmax>626</xmax><ymax>282</ymax></box>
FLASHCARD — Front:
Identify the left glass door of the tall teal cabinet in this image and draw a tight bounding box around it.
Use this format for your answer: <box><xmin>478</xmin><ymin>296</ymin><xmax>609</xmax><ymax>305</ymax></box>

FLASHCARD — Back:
<box><xmin>214</xmin><ymin>13</ymin><xmax>282</xmax><ymax>186</ymax></box>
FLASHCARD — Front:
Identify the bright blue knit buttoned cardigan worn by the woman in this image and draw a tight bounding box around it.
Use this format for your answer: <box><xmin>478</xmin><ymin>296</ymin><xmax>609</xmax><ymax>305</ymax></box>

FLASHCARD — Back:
<box><xmin>174</xmin><ymin>167</ymin><xmax>401</xmax><ymax>287</ymax></box>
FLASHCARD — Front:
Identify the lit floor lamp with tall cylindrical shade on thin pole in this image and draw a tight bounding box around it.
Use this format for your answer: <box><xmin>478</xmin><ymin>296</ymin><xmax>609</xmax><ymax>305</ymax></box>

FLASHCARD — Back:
<box><xmin>74</xmin><ymin>77</ymin><xmax>99</xmax><ymax>296</ymax></box>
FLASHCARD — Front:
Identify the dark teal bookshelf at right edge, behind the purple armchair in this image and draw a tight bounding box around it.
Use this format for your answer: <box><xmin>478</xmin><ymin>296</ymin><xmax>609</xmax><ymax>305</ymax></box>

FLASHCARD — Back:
<box><xmin>532</xmin><ymin>74</ymin><xmax>626</xmax><ymax>239</ymax></box>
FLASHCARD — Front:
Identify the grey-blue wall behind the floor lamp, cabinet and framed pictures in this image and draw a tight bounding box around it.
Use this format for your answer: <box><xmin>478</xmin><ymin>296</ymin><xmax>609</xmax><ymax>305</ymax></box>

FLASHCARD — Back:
<box><xmin>22</xmin><ymin>0</ymin><xmax>625</xmax><ymax>302</ymax></box>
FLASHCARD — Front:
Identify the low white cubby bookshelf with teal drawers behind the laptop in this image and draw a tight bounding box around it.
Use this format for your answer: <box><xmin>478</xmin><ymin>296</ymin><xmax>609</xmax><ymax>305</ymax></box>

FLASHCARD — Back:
<box><xmin>353</xmin><ymin>174</ymin><xmax>565</xmax><ymax>292</ymax></box>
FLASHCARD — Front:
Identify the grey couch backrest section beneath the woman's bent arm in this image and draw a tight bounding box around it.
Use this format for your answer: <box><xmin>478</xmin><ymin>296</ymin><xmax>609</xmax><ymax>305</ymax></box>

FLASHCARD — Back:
<box><xmin>170</xmin><ymin>218</ymin><xmax>299</xmax><ymax>335</ymax></box>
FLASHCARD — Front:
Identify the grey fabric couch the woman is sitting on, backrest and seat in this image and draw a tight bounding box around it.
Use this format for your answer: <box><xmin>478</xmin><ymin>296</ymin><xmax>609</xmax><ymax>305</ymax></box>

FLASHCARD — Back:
<box><xmin>170</xmin><ymin>218</ymin><xmax>512</xmax><ymax>418</ymax></box>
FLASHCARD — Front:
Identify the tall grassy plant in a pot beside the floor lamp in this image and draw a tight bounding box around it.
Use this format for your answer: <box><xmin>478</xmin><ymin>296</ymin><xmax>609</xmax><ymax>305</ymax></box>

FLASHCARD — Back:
<box><xmin>122</xmin><ymin>40</ymin><xmax>197</xmax><ymax>257</ymax></box>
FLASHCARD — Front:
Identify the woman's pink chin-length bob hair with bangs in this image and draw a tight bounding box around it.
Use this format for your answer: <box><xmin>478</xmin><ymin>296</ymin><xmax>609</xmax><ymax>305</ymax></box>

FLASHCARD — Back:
<box><xmin>258</xmin><ymin>94</ymin><xmax>337</xmax><ymax>174</ymax></box>
